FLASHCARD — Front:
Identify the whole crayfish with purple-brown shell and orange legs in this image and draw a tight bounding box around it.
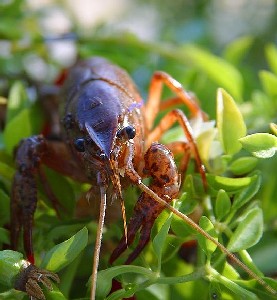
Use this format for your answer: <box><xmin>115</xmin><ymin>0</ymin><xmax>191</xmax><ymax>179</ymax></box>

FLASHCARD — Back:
<box><xmin>11</xmin><ymin>57</ymin><xmax>274</xmax><ymax>299</ymax></box>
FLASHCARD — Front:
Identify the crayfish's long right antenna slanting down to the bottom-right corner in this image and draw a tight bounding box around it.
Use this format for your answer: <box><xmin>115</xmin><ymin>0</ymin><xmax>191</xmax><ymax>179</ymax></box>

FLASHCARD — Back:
<box><xmin>139</xmin><ymin>181</ymin><xmax>277</xmax><ymax>295</ymax></box>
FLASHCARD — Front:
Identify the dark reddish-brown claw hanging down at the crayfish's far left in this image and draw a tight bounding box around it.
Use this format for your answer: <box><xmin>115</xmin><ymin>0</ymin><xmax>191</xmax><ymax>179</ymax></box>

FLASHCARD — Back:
<box><xmin>11</xmin><ymin>136</ymin><xmax>45</xmax><ymax>263</ymax></box>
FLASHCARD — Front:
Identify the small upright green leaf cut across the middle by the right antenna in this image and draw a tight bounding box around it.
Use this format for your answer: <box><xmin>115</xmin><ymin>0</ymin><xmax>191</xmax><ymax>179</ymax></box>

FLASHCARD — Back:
<box><xmin>197</xmin><ymin>216</ymin><xmax>217</xmax><ymax>257</ymax></box>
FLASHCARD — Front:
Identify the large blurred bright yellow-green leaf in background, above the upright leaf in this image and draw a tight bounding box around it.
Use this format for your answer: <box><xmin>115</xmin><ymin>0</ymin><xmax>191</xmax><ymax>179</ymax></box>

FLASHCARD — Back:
<box><xmin>183</xmin><ymin>45</ymin><xmax>243</xmax><ymax>100</ymax></box>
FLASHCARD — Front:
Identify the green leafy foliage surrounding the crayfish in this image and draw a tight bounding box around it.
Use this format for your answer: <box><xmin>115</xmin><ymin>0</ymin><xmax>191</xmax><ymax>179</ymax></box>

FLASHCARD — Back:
<box><xmin>0</xmin><ymin>1</ymin><xmax>277</xmax><ymax>300</ymax></box>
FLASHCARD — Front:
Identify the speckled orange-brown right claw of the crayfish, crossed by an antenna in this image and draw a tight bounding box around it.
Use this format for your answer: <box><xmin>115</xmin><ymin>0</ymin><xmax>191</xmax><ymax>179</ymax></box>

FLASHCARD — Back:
<box><xmin>110</xmin><ymin>143</ymin><xmax>179</xmax><ymax>264</ymax></box>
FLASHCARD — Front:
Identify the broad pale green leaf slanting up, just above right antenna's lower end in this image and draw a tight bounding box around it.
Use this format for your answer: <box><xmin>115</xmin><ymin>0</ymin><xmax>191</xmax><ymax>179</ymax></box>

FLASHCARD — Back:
<box><xmin>227</xmin><ymin>207</ymin><xmax>263</xmax><ymax>252</ymax></box>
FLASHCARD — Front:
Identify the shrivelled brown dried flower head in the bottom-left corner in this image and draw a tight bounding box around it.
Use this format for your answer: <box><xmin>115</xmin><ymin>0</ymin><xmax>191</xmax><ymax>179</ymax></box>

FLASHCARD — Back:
<box><xmin>14</xmin><ymin>264</ymin><xmax>60</xmax><ymax>300</ymax></box>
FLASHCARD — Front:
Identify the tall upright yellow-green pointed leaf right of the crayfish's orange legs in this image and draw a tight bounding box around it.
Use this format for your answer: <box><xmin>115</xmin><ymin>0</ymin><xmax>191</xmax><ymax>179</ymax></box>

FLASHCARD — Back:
<box><xmin>217</xmin><ymin>89</ymin><xmax>246</xmax><ymax>155</ymax></box>
